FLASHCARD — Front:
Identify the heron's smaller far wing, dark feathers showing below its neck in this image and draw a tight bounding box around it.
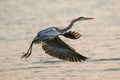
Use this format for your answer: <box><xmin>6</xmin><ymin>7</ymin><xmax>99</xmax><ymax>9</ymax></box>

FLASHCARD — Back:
<box><xmin>62</xmin><ymin>31</ymin><xmax>81</xmax><ymax>39</ymax></box>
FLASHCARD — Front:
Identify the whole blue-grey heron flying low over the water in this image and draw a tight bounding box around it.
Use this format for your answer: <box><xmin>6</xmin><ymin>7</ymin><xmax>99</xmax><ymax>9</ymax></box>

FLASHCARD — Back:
<box><xmin>21</xmin><ymin>17</ymin><xmax>93</xmax><ymax>62</ymax></box>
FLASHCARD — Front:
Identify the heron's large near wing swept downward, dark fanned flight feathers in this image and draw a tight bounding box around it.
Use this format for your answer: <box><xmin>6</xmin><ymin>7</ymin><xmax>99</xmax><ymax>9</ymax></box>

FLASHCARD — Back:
<box><xmin>42</xmin><ymin>37</ymin><xmax>87</xmax><ymax>62</ymax></box>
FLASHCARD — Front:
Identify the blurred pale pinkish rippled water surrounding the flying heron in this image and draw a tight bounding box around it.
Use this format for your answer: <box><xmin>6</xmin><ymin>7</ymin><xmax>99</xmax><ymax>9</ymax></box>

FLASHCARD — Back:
<box><xmin>0</xmin><ymin>0</ymin><xmax>120</xmax><ymax>80</ymax></box>
